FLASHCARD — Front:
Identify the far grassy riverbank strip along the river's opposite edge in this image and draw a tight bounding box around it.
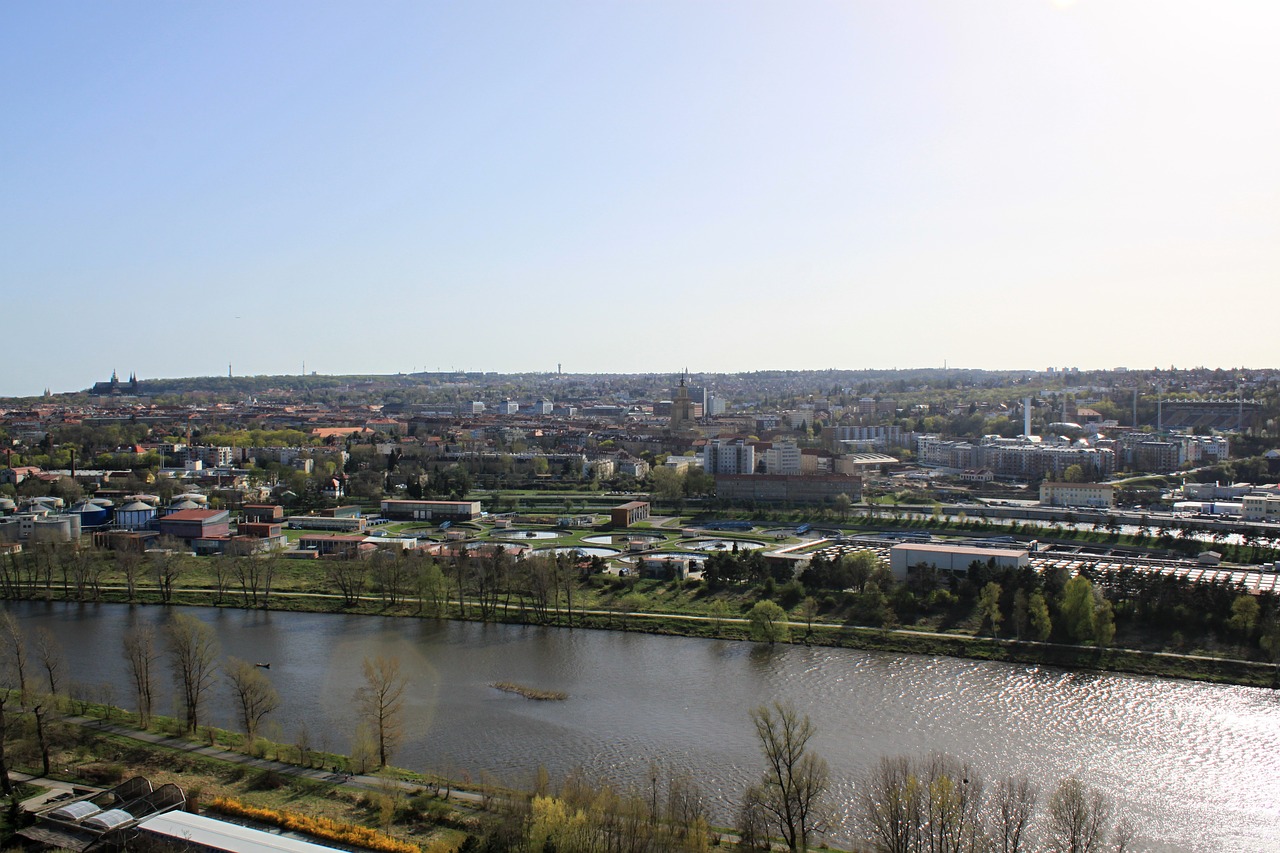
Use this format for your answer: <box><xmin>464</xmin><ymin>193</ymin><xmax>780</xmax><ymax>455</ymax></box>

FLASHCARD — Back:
<box><xmin>20</xmin><ymin>588</ymin><xmax>1280</xmax><ymax>689</ymax></box>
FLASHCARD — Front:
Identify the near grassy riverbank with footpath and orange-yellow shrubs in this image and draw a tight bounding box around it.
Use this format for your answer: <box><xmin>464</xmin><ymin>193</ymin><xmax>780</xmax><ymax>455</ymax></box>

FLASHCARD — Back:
<box><xmin>0</xmin><ymin>704</ymin><xmax>742</xmax><ymax>853</ymax></box>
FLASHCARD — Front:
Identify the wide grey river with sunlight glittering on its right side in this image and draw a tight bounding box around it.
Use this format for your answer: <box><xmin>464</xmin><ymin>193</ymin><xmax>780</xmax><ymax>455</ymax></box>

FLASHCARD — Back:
<box><xmin>4</xmin><ymin>602</ymin><xmax>1280</xmax><ymax>852</ymax></box>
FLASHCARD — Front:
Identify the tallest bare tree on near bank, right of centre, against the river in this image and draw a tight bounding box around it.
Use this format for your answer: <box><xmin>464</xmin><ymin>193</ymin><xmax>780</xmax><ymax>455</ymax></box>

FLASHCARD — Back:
<box><xmin>751</xmin><ymin>702</ymin><xmax>831</xmax><ymax>850</ymax></box>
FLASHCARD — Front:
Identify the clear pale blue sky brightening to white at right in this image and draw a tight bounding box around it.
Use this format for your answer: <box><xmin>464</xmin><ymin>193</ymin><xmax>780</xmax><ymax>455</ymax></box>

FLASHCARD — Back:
<box><xmin>0</xmin><ymin>0</ymin><xmax>1280</xmax><ymax>394</ymax></box>
